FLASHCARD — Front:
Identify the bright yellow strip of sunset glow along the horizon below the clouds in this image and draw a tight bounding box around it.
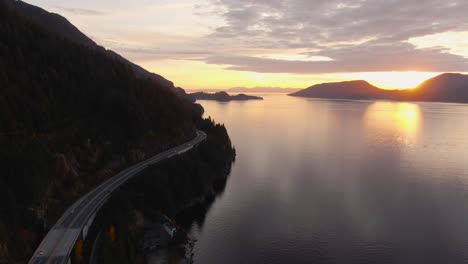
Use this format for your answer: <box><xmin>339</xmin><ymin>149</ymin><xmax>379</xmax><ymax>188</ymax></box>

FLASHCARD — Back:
<box><xmin>141</xmin><ymin>60</ymin><xmax>439</xmax><ymax>89</ymax></box>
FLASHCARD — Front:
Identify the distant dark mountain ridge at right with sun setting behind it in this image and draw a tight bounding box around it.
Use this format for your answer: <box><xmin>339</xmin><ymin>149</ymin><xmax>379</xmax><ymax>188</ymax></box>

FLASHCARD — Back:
<box><xmin>289</xmin><ymin>73</ymin><xmax>468</xmax><ymax>103</ymax></box>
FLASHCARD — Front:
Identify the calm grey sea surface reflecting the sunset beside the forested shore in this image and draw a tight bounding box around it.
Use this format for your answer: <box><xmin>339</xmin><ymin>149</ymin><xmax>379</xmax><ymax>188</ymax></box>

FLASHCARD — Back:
<box><xmin>158</xmin><ymin>94</ymin><xmax>468</xmax><ymax>264</ymax></box>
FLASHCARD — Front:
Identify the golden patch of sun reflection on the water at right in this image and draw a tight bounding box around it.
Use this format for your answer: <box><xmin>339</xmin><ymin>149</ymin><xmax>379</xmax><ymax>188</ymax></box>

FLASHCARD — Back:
<box><xmin>365</xmin><ymin>102</ymin><xmax>421</xmax><ymax>143</ymax></box>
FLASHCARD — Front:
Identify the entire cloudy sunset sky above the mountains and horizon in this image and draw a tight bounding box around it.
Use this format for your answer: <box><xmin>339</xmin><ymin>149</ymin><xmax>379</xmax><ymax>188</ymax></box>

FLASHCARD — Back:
<box><xmin>26</xmin><ymin>0</ymin><xmax>468</xmax><ymax>89</ymax></box>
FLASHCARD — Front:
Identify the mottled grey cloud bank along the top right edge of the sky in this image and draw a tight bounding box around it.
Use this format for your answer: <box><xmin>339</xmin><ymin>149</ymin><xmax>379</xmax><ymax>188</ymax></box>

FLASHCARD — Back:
<box><xmin>209</xmin><ymin>0</ymin><xmax>468</xmax><ymax>44</ymax></box>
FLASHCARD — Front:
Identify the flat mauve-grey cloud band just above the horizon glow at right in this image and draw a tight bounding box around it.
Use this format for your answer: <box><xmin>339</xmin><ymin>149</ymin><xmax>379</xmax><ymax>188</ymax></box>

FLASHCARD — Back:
<box><xmin>203</xmin><ymin>42</ymin><xmax>468</xmax><ymax>74</ymax></box>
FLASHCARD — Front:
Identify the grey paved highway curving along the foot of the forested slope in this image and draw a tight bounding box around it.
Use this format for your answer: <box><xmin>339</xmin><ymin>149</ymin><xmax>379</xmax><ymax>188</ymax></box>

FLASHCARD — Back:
<box><xmin>29</xmin><ymin>130</ymin><xmax>207</xmax><ymax>264</ymax></box>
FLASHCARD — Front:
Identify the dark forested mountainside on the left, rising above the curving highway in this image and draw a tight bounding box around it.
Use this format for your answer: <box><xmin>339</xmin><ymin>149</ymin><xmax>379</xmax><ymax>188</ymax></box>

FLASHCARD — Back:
<box><xmin>0</xmin><ymin>0</ymin><xmax>235</xmax><ymax>263</ymax></box>
